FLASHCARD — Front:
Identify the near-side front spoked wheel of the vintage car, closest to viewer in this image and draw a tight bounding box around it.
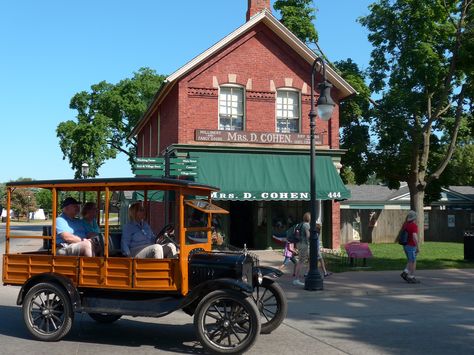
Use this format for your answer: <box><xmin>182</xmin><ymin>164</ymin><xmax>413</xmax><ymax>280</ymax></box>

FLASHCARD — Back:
<box><xmin>194</xmin><ymin>290</ymin><xmax>261</xmax><ymax>354</ymax></box>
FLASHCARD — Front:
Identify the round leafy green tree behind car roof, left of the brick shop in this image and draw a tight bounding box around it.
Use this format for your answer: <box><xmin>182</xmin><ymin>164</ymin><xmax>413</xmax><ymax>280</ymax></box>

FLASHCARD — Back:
<box><xmin>56</xmin><ymin>68</ymin><xmax>164</xmax><ymax>178</ymax></box>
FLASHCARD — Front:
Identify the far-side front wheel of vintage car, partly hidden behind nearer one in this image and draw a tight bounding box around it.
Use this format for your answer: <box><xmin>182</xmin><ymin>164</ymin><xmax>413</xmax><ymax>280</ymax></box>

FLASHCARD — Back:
<box><xmin>253</xmin><ymin>279</ymin><xmax>288</xmax><ymax>334</ymax></box>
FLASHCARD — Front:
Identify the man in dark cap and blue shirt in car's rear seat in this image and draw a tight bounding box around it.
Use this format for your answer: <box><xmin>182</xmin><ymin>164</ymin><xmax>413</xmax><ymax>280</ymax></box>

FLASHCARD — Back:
<box><xmin>56</xmin><ymin>197</ymin><xmax>93</xmax><ymax>256</ymax></box>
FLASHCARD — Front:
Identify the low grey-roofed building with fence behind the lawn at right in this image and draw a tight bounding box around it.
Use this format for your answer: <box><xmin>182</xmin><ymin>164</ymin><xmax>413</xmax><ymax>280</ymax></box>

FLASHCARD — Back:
<box><xmin>341</xmin><ymin>183</ymin><xmax>474</xmax><ymax>244</ymax></box>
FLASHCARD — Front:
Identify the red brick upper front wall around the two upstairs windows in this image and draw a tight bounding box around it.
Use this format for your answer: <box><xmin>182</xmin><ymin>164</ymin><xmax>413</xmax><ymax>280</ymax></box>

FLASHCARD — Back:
<box><xmin>179</xmin><ymin>24</ymin><xmax>339</xmax><ymax>148</ymax></box>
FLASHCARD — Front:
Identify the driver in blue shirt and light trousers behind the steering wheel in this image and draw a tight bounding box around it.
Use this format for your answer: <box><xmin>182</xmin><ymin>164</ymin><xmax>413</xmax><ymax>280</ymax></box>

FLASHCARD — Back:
<box><xmin>121</xmin><ymin>202</ymin><xmax>177</xmax><ymax>259</ymax></box>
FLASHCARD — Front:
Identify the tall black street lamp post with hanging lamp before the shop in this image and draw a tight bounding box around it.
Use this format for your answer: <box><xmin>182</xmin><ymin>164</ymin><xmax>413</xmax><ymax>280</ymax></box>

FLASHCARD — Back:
<box><xmin>304</xmin><ymin>57</ymin><xmax>335</xmax><ymax>291</ymax></box>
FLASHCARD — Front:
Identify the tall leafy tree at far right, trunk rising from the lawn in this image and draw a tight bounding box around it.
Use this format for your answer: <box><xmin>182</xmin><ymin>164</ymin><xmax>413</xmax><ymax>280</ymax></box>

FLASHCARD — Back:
<box><xmin>360</xmin><ymin>0</ymin><xmax>474</xmax><ymax>242</ymax></box>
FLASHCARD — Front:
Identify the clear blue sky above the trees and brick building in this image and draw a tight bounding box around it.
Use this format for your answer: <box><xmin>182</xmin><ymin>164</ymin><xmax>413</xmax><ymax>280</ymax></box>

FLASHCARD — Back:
<box><xmin>0</xmin><ymin>0</ymin><xmax>373</xmax><ymax>182</ymax></box>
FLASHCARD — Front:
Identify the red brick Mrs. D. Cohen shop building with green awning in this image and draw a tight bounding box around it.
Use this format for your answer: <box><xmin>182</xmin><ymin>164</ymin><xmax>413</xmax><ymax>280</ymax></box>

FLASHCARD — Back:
<box><xmin>132</xmin><ymin>0</ymin><xmax>355</xmax><ymax>248</ymax></box>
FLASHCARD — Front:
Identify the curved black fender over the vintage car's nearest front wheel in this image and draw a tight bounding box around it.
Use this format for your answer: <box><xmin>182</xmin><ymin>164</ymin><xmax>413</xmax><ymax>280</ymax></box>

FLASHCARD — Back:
<box><xmin>180</xmin><ymin>278</ymin><xmax>253</xmax><ymax>308</ymax></box>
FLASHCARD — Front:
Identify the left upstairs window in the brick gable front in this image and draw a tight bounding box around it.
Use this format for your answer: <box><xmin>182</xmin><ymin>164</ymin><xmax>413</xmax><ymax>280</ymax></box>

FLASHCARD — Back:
<box><xmin>219</xmin><ymin>86</ymin><xmax>244</xmax><ymax>131</ymax></box>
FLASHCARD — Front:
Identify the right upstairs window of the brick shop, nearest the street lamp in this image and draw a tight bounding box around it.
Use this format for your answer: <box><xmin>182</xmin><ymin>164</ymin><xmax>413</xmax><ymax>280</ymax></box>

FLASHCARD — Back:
<box><xmin>276</xmin><ymin>90</ymin><xmax>300</xmax><ymax>133</ymax></box>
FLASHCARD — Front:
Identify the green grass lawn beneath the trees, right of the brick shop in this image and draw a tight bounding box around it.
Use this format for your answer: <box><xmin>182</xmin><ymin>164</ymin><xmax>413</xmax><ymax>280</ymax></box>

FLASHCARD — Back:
<box><xmin>324</xmin><ymin>242</ymin><xmax>474</xmax><ymax>272</ymax></box>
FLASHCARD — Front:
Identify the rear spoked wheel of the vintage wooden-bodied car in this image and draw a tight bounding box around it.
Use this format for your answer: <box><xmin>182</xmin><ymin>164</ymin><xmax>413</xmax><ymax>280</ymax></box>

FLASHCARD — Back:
<box><xmin>23</xmin><ymin>282</ymin><xmax>74</xmax><ymax>341</ymax></box>
